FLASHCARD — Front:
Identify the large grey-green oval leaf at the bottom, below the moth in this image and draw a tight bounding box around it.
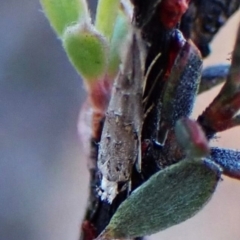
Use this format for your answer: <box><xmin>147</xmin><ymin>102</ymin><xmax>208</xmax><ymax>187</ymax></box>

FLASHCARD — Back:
<box><xmin>97</xmin><ymin>159</ymin><xmax>221</xmax><ymax>240</ymax></box>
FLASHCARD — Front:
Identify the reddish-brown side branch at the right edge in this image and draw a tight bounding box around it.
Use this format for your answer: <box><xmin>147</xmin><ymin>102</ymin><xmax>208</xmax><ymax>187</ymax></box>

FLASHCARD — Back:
<box><xmin>198</xmin><ymin>23</ymin><xmax>240</xmax><ymax>138</ymax></box>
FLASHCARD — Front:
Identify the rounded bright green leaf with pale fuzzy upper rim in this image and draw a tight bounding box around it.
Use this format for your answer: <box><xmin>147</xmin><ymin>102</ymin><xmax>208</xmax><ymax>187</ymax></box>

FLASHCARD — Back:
<box><xmin>63</xmin><ymin>23</ymin><xmax>108</xmax><ymax>84</ymax></box>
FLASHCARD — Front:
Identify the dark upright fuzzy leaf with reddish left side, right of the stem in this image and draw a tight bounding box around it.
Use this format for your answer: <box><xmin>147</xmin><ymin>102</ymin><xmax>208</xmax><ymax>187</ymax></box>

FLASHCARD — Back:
<box><xmin>162</xmin><ymin>38</ymin><xmax>202</xmax><ymax>127</ymax></box>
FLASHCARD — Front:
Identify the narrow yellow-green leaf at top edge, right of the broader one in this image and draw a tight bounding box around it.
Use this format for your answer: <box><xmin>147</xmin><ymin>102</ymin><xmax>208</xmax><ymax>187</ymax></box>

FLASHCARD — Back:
<box><xmin>95</xmin><ymin>0</ymin><xmax>120</xmax><ymax>40</ymax></box>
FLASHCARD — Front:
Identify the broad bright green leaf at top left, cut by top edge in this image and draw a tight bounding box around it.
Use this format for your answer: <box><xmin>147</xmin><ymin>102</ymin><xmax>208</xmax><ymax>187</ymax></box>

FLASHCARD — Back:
<box><xmin>40</xmin><ymin>0</ymin><xmax>90</xmax><ymax>37</ymax></box>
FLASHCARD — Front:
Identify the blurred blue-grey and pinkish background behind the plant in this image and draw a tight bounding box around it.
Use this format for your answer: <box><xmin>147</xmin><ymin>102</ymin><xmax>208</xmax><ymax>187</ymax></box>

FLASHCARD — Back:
<box><xmin>0</xmin><ymin>0</ymin><xmax>240</xmax><ymax>240</ymax></box>
